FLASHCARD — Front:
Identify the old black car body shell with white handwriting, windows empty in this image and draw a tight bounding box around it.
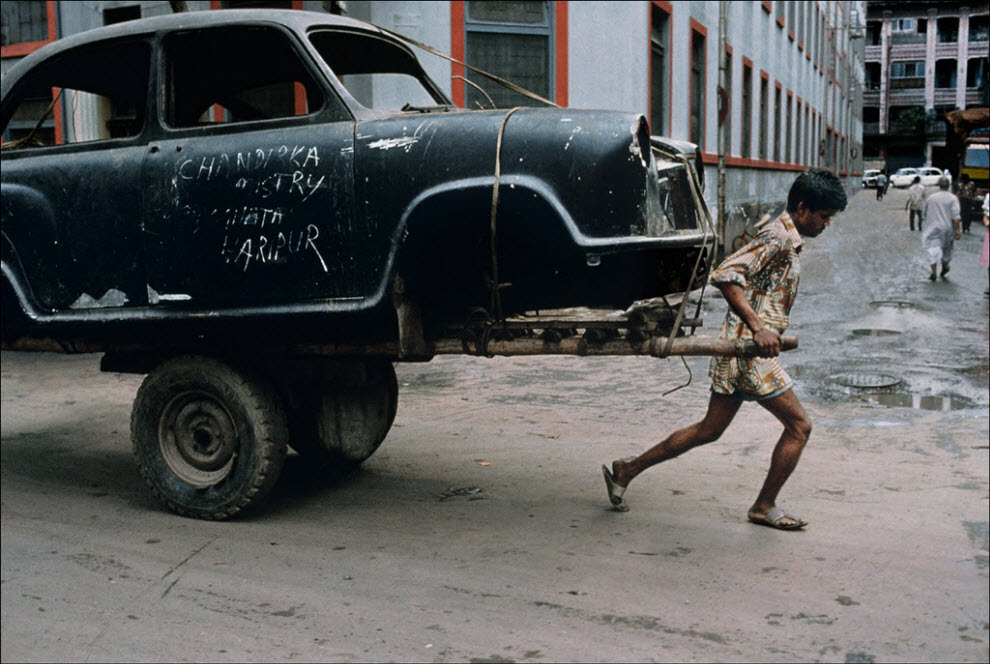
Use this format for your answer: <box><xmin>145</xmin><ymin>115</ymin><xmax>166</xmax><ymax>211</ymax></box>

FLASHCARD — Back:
<box><xmin>0</xmin><ymin>10</ymin><xmax>711</xmax><ymax>343</ymax></box>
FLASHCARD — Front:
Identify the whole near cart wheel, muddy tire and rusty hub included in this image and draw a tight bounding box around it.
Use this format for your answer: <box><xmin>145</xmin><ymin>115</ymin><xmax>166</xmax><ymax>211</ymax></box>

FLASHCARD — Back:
<box><xmin>131</xmin><ymin>356</ymin><xmax>288</xmax><ymax>519</ymax></box>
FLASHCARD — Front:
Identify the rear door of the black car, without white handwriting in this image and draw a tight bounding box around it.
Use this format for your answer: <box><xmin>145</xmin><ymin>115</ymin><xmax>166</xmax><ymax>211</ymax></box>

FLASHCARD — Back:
<box><xmin>3</xmin><ymin>31</ymin><xmax>155</xmax><ymax>320</ymax></box>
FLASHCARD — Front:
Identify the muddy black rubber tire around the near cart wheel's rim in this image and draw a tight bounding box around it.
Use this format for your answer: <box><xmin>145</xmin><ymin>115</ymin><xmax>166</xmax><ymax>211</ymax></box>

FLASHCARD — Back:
<box><xmin>131</xmin><ymin>356</ymin><xmax>288</xmax><ymax>520</ymax></box>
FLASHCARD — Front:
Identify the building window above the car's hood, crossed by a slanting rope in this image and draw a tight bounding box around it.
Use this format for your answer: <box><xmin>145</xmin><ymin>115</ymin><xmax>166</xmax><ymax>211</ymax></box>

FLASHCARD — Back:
<box><xmin>464</xmin><ymin>0</ymin><xmax>553</xmax><ymax>108</ymax></box>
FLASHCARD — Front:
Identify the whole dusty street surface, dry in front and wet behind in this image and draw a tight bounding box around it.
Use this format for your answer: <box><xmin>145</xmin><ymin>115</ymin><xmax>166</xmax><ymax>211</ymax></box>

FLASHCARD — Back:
<box><xmin>0</xmin><ymin>190</ymin><xmax>990</xmax><ymax>662</ymax></box>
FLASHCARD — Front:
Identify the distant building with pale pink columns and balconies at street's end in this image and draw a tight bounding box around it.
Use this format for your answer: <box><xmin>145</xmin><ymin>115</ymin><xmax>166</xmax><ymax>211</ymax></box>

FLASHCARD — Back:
<box><xmin>863</xmin><ymin>0</ymin><xmax>990</xmax><ymax>170</ymax></box>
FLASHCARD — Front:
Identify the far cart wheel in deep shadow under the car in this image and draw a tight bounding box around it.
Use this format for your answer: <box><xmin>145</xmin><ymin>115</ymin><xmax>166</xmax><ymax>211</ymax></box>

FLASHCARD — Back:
<box><xmin>283</xmin><ymin>360</ymin><xmax>399</xmax><ymax>467</ymax></box>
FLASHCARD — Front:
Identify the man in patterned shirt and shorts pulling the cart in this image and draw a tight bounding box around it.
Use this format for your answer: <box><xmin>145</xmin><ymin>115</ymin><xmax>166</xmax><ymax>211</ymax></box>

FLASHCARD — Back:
<box><xmin>602</xmin><ymin>169</ymin><xmax>846</xmax><ymax>530</ymax></box>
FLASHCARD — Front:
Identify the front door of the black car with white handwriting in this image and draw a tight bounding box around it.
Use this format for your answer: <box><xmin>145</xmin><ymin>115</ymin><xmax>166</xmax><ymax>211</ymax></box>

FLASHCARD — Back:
<box><xmin>142</xmin><ymin>21</ymin><xmax>358</xmax><ymax>313</ymax></box>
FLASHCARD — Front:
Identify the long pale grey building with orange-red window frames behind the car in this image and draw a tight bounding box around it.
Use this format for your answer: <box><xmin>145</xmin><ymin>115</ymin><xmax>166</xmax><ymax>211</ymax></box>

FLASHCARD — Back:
<box><xmin>0</xmin><ymin>0</ymin><xmax>866</xmax><ymax>247</ymax></box>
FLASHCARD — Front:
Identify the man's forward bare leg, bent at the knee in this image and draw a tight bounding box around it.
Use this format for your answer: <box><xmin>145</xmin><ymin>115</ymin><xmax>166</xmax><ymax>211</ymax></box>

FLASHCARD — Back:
<box><xmin>749</xmin><ymin>390</ymin><xmax>811</xmax><ymax>525</ymax></box>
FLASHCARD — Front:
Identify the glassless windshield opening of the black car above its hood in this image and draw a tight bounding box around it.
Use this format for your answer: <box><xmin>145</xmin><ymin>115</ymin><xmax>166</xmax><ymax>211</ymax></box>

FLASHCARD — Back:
<box><xmin>309</xmin><ymin>30</ymin><xmax>449</xmax><ymax>110</ymax></box>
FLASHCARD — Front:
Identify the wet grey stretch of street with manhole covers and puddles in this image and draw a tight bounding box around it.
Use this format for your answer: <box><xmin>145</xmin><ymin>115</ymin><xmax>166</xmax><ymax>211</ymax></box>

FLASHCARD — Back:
<box><xmin>787</xmin><ymin>188</ymin><xmax>990</xmax><ymax>412</ymax></box>
